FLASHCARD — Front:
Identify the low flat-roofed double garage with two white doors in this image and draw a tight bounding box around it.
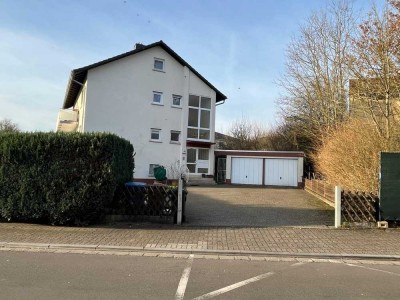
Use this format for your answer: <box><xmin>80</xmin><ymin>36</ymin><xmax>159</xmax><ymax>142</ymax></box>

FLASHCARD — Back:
<box><xmin>215</xmin><ymin>150</ymin><xmax>304</xmax><ymax>187</ymax></box>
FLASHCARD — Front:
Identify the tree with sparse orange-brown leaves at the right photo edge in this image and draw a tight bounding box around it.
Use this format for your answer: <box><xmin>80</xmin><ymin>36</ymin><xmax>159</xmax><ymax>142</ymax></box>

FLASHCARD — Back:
<box><xmin>349</xmin><ymin>0</ymin><xmax>400</xmax><ymax>140</ymax></box>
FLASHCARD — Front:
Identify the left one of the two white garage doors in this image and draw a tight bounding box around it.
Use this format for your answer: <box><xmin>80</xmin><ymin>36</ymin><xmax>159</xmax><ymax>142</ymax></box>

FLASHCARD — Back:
<box><xmin>231</xmin><ymin>157</ymin><xmax>263</xmax><ymax>185</ymax></box>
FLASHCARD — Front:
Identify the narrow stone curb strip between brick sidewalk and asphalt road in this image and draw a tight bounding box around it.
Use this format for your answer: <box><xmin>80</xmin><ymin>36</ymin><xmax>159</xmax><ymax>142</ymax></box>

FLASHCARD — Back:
<box><xmin>0</xmin><ymin>242</ymin><xmax>400</xmax><ymax>261</ymax></box>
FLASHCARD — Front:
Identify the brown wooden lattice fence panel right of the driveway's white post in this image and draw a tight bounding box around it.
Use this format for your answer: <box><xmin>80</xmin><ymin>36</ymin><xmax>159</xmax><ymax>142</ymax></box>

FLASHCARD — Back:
<box><xmin>341</xmin><ymin>191</ymin><xmax>379</xmax><ymax>223</ymax></box>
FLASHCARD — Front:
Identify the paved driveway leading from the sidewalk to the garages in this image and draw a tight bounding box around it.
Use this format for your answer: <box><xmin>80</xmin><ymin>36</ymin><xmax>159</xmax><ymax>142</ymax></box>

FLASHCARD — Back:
<box><xmin>186</xmin><ymin>186</ymin><xmax>334</xmax><ymax>227</ymax></box>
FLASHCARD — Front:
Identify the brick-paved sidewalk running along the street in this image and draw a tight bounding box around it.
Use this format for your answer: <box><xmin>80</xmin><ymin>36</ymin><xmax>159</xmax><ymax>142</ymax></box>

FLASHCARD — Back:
<box><xmin>0</xmin><ymin>223</ymin><xmax>400</xmax><ymax>260</ymax></box>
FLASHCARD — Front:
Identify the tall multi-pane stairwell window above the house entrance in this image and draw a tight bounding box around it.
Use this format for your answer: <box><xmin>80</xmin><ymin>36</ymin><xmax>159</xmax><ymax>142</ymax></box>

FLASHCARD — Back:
<box><xmin>187</xmin><ymin>95</ymin><xmax>211</xmax><ymax>141</ymax></box>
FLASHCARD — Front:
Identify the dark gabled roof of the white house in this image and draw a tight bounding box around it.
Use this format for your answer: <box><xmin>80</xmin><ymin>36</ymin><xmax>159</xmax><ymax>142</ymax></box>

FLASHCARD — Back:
<box><xmin>63</xmin><ymin>41</ymin><xmax>226</xmax><ymax>108</ymax></box>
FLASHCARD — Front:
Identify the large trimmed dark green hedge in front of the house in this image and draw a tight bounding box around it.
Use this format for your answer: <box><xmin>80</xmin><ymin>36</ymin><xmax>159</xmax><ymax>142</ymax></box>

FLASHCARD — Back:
<box><xmin>0</xmin><ymin>133</ymin><xmax>134</xmax><ymax>224</ymax></box>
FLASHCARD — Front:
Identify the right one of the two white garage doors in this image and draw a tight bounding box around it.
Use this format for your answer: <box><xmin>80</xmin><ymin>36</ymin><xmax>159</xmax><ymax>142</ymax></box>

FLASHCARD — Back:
<box><xmin>265</xmin><ymin>159</ymin><xmax>297</xmax><ymax>187</ymax></box>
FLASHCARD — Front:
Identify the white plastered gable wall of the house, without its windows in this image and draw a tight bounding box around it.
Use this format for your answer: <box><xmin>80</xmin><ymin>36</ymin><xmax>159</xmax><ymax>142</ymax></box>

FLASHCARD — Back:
<box><xmin>83</xmin><ymin>47</ymin><xmax>216</xmax><ymax>179</ymax></box>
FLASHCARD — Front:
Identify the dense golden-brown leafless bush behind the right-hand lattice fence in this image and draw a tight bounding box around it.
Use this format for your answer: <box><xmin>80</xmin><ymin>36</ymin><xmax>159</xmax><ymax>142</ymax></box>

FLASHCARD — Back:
<box><xmin>314</xmin><ymin>119</ymin><xmax>400</xmax><ymax>193</ymax></box>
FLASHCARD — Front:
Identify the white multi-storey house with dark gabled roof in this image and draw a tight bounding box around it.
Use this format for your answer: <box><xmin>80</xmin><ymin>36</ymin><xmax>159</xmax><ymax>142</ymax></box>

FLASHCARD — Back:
<box><xmin>57</xmin><ymin>41</ymin><xmax>226</xmax><ymax>181</ymax></box>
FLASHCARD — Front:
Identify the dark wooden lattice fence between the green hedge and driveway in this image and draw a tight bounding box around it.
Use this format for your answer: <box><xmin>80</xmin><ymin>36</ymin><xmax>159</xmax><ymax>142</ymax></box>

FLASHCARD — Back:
<box><xmin>125</xmin><ymin>185</ymin><xmax>187</xmax><ymax>223</ymax></box>
